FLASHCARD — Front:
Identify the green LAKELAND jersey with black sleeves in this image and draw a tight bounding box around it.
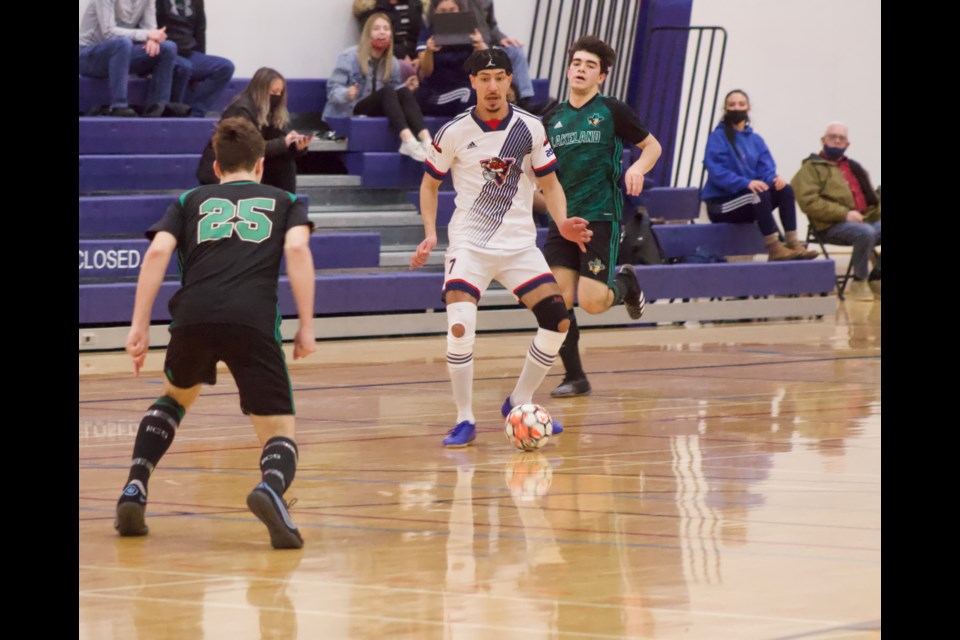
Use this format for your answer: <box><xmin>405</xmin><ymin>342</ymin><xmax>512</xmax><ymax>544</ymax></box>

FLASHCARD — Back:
<box><xmin>544</xmin><ymin>94</ymin><xmax>650</xmax><ymax>222</ymax></box>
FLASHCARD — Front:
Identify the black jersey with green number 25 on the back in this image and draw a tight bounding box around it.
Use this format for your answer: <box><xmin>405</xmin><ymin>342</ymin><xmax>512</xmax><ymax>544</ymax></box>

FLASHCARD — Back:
<box><xmin>146</xmin><ymin>182</ymin><xmax>312</xmax><ymax>336</ymax></box>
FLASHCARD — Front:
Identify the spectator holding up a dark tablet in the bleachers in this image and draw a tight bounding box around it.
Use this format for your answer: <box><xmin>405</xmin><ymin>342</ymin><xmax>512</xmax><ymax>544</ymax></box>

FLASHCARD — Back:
<box><xmin>415</xmin><ymin>0</ymin><xmax>487</xmax><ymax>116</ymax></box>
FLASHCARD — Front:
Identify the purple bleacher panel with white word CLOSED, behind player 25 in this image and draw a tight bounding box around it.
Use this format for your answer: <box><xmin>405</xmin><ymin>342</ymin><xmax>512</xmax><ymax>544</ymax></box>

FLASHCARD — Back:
<box><xmin>80</xmin><ymin>232</ymin><xmax>380</xmax><ymax>278</ymax></box>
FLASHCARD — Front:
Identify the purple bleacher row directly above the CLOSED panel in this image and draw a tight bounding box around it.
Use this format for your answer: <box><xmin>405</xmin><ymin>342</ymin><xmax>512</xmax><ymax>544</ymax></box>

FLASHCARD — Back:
<box><xmin>79</xmin><ymin>194</ymin><xmax>310</xmax><ymax>238</ymax></box>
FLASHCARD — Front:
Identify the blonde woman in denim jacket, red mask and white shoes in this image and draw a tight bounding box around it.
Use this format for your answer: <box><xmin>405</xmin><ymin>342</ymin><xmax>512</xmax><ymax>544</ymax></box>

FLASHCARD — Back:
<box><xmin>323</xmin><ymin>13</ymin><xmax>432</xmax><ymax>162</ymax></box>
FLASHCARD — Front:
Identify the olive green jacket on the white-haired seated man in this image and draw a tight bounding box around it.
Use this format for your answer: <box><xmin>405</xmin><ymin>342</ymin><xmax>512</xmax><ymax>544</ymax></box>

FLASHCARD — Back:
<box><xmin>790</xmin><ymin>153</ymin><xmax>880</xmax><ymax>231</ymax></box>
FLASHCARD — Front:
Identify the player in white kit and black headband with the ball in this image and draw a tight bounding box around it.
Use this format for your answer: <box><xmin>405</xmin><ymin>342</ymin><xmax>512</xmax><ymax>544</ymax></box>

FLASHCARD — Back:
<box><xmin>410</xmin><ymin>49</ymin><xmax>593</xmax><ymax>447</ymax></box>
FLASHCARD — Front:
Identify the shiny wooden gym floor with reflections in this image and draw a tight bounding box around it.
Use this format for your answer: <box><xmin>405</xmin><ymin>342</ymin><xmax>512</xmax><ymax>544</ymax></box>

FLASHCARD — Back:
<box><xmin>79</xmin><ymin>302</ymin><xmax>881</xmax><ymax>640</ymax></box>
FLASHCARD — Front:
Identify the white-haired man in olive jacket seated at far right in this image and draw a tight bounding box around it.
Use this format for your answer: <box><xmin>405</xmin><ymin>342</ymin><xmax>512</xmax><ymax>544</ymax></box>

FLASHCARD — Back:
<box><xmin>790</xmin><ymin>122</ymin><xmax>880</xmax><ymax>301</ymax></box>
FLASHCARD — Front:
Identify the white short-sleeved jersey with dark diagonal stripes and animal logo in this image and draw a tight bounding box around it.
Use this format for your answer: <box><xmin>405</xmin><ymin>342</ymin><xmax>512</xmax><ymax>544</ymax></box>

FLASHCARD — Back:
<box><xmin>426</xmin><ymin>105</ymin><xmax>557</xmax><ymax>249</ymax></box>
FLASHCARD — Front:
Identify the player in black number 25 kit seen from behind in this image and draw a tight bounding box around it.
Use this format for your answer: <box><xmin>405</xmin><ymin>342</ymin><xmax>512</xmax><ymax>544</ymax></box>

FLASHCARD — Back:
<box><xmin>115</xmin><ymin>118</ymin><xmax>316</xmax><ymax>548</ymax></box>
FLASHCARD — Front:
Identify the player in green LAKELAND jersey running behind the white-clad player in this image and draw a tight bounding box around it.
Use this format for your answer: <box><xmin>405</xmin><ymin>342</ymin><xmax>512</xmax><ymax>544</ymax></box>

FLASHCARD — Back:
<box><xmin>543</xmin><ymin>36</ymin><xmax>661</xmax><ymax>397</ymax></box>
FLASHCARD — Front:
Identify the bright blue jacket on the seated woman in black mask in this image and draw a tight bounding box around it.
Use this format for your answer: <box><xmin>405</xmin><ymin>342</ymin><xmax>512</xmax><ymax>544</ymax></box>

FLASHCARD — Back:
<box><xmin>700</xmin><ymin>123</ymin><xmax>777</xmax><ymax>200</ymax></box>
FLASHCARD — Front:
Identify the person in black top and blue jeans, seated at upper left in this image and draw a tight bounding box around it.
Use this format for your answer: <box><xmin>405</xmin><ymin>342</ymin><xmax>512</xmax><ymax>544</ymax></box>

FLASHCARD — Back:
<box><xmin>157</xmin><ymin>0</ymin><xmax>233</xmax><ymax>118</ymax></box>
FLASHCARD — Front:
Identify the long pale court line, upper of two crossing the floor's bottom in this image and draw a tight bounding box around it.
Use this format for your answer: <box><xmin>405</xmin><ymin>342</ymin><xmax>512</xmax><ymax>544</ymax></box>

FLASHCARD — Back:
<box><xmin>78</xmin><ymin>565</ymin><xmax>847</xmax><ymax>638</ymax></box>
